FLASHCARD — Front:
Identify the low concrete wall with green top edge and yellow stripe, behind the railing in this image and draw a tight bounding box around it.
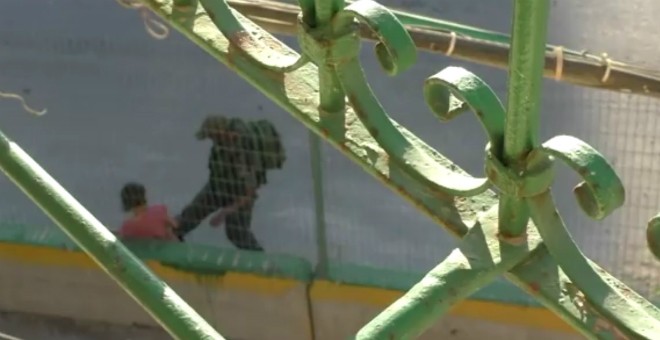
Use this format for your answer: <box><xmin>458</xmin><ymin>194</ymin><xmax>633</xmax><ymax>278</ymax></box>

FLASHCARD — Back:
<box><xmin>0</xmin><ymin>228</ymin><xmax>577</xmax><ymax>340</ymax></box>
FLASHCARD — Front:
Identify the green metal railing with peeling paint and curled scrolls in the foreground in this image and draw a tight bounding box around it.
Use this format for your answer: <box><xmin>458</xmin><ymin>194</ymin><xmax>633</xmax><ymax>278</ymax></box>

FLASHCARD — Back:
<box><xmin>0</xmin><ymin>0</ymin><xmax>660</xmax><ymax>340</ymax></box>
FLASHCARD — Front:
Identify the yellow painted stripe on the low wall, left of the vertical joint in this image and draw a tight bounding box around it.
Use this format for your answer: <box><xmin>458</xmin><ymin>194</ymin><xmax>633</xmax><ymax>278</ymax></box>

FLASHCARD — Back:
<box><xmin>0</xmin><ymin>243</ymin><xmax>301</xmax><ymax>295</ymax></box>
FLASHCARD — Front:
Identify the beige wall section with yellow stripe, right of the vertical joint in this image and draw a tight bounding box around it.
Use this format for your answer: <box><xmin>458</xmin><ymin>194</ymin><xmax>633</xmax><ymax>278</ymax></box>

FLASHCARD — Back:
<box><xmin>311</xmin><ymin>281</ymin><xmax>582</xmax><ymax>340</ymax></box>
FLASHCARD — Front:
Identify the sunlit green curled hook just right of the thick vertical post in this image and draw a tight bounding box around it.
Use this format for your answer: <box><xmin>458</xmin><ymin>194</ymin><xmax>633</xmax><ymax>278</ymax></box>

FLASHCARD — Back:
<box><xmin>528</xmin><ymin>136</ymin><xmax>626</xmax><ymax>220</ymax></box>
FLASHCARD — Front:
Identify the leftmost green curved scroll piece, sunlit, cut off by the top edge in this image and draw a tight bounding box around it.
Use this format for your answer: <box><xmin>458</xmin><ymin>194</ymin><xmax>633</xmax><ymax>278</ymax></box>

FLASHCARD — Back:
<box><xmin>200</xmin><ymin>0</ymin><xmax>309</xmax><ymax>73</ymax></box>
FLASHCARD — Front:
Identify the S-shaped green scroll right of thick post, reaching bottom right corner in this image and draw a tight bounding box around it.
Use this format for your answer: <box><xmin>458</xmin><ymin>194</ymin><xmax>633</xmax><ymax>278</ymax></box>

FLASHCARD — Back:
<box><xmin>527</xmin><ymin>136</ymin><xmax>660</xmax><ymax>339</ymax></box>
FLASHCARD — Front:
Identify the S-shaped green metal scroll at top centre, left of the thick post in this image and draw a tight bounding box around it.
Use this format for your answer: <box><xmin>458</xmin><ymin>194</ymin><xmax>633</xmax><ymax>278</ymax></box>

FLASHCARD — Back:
<box><xmin>299</xmin><ymin>0</ymin><xmax>501</xmax><ymax>196</ymax></box>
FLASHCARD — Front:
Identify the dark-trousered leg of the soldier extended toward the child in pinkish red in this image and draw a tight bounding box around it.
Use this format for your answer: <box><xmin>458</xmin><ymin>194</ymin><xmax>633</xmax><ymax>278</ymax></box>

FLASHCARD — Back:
<box><xmin>174</xmin><ymin>184</ymin><xmax>222</xmax><ymax>241</ymax></box>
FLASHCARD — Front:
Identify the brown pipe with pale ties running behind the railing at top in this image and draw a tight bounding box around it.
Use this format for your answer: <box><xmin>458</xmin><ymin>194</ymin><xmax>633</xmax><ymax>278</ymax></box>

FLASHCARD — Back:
<box><xmin>228</xmin><ymin>0</ymin><xmax>660</xmax><ymax>97</ymax></box>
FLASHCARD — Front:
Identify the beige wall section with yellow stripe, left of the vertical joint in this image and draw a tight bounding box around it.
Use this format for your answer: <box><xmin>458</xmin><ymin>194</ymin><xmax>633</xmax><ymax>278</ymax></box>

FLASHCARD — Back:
<box><xmin>0</xmin><ymin>239</ymin><xmax>312</xmax><ymax>340</ymax></box>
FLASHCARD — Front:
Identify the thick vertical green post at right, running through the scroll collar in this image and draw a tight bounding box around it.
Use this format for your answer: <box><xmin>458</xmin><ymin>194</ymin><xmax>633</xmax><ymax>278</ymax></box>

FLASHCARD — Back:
<box><xmin>499</xmin><ymin>0</ymin><xmax>550</xmax><ymax>237</ymax></box>
